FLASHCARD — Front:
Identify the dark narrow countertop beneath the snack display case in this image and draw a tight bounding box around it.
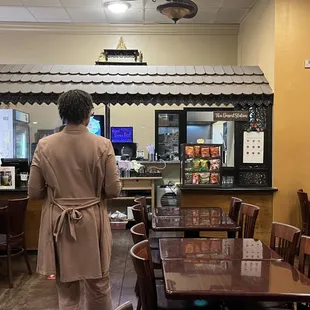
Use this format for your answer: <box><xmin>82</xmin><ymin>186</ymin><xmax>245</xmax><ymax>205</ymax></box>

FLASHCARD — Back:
<box><xmin>180</xmin><ymin>185</ymin><xmax>278</xmax><ymax>193</ymax></box>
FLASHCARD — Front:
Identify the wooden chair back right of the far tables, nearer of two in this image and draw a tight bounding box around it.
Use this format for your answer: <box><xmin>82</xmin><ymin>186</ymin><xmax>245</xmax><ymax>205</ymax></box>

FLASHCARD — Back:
<box><xmin>239</xmin><ymin>203</ymin><xmax>259</xmax><ymax>238</ymax></box>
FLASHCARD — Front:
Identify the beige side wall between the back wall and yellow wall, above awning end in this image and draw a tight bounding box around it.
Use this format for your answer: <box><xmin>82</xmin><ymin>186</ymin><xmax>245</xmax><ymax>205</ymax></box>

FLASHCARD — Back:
<box><xmin>238</xmin><ymin>0</ymin><xmax>275</xmax><ymax>88</ymax></box>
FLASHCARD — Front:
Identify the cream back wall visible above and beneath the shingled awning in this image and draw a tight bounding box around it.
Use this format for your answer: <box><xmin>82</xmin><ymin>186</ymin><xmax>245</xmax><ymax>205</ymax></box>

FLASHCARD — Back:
<box><xmin>0</xmin><ymin>24</ymin><xmax>238</xmax><ymax>150</ymax></box>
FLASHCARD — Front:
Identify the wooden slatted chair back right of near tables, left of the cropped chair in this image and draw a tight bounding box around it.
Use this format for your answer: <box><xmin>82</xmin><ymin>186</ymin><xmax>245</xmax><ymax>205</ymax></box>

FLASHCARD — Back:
<box><xmin>270</xmin><ymin>222</ymin><xmax>301</xmax><ymax>265</ymax></box>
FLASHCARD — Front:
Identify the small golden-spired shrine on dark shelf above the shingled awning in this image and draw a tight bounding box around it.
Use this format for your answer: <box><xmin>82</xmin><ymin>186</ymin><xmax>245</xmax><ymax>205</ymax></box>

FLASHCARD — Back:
<box><xmin>96</xmin><ymin>37</ymin><xmax>147</xmax><ymax>66</ymax></box>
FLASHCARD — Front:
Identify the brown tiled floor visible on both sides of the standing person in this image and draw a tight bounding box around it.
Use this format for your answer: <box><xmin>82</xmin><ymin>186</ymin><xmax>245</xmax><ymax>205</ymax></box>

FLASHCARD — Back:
<box><xmin>0</xmin><ymin>230</ymin><xmax>136</xmax><ymax>310</ymax></box>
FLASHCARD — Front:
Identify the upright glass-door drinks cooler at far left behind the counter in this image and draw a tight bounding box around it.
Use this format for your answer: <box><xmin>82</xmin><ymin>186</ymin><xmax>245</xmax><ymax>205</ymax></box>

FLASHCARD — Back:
<box><xmin>0</xmin><ymin>109</ymin><xmax>30</xmax><ymax>159</ymax></box>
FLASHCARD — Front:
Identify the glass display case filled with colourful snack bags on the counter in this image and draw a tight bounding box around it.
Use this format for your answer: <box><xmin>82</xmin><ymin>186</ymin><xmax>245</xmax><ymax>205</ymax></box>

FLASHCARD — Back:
<box><xmin>181</xmin><ymin>144</ymin><xmax>223</xmax><ymax>187</ymax></box>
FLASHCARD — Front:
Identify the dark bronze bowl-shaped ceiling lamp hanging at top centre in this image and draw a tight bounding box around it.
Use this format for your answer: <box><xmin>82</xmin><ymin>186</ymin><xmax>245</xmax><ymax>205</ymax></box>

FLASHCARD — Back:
<box><xmin>152</xmin><ymin>0</ymin><xmax>198</xmax><ymax>23</ymax></box>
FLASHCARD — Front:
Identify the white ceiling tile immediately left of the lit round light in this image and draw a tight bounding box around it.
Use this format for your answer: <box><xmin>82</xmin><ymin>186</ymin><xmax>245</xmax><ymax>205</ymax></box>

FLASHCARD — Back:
<box><xmin>67</xmin><ymin>8</ymin><xmax>106</xmax><ymax>23</ymax></box>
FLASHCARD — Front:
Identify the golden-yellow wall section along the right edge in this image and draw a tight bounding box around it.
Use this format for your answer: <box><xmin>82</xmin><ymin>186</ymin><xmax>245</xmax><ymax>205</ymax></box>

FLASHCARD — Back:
<box><xmin>274</xmin><ymin>0</ymin><xmax>310</xmax><ymax>225</ymax></box>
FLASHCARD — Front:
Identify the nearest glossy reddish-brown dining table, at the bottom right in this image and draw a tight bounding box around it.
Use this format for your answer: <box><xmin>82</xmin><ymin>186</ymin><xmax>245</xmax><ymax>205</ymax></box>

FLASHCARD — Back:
<box><xmin>162</xmin><ymin>259</ymin><xmax>310</xmax><ymax>302</ymax></box>
